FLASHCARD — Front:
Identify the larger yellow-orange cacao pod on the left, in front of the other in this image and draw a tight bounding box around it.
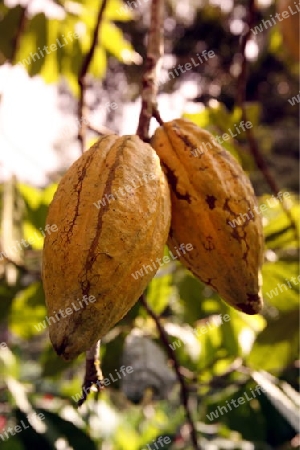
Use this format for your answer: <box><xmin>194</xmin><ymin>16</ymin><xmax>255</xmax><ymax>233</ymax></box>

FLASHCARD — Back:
<box><xmin>42</xmin><ymin>135</ymin><xmax>171</xmax><ymax>359</ymax></box>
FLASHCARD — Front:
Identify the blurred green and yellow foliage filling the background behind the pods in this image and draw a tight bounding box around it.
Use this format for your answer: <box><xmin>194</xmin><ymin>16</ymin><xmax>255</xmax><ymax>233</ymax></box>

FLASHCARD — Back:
<box><xmin>0</xmin><ymin>0</ymin><xmax>300</xmax><ymax>450</ymax></box>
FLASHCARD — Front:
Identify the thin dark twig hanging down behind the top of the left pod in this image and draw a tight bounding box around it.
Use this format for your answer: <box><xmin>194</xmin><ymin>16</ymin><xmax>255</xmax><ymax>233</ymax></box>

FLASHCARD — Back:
<box><xmin>78</xmin><ymin>0</ymin><xmax>108</xmax><ymax>153</ymax></box>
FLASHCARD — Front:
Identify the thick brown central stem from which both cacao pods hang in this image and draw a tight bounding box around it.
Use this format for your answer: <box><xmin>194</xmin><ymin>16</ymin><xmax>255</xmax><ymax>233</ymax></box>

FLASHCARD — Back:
<box><xmin>136</xmin><ymin>0</ymin><xmax>164</xmax><ymax>141</ymax></box>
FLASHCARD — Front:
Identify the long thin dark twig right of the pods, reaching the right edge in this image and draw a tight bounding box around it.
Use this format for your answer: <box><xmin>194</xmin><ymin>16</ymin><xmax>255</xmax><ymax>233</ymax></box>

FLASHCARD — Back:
<box><xmin>236</xmin><ymin>0</ymin><xmax>298</xmax><ymax>241</ymax></box>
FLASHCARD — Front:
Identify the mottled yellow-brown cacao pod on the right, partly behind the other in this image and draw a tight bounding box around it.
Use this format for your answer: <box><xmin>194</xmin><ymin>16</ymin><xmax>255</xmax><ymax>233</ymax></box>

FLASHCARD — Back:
<box><xmin>151</xmin><ymin>119</ymin><xmax>263</xmax><ymax>314</ymax></box>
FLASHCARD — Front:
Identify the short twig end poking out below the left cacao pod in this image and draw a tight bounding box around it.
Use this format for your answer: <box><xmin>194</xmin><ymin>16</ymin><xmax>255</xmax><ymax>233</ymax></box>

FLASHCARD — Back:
<box><xmin>77</xmin><ymin>341</ymin><xmax>104</xmax><ymax>407</ymax></box>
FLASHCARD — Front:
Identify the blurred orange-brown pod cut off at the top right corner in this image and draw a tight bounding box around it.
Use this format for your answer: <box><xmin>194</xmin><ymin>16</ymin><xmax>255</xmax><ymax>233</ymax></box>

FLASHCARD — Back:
<box><xmin>277</xmin><ymin>0</ymin><xmax>300</xmax><ymax>61</ymax></box>
